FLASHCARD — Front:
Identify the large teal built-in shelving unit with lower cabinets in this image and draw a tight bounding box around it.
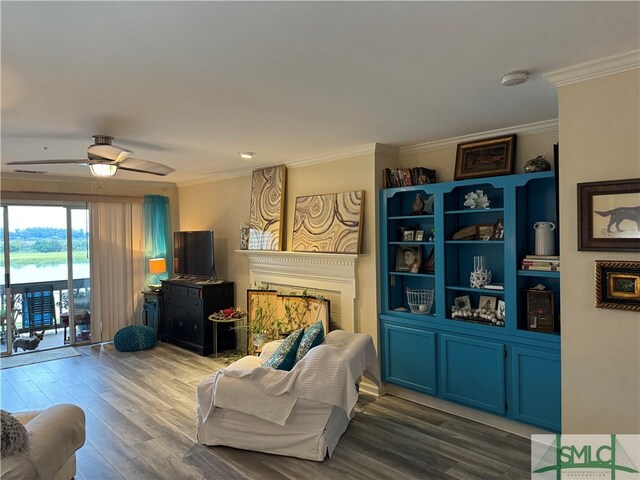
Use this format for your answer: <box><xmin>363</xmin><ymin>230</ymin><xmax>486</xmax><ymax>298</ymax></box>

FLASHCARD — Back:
<box><xmin>379</xmin><ymin>172</ymin><xmax>560</xmax><ymax>431</ymax></box>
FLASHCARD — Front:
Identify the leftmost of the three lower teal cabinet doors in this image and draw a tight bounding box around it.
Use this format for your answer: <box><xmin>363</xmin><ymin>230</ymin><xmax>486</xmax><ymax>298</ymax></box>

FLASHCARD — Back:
<box><xmin>383</xmin><ymin>323</ymin><xmax>437</xmax><ymax>395</ymax></box>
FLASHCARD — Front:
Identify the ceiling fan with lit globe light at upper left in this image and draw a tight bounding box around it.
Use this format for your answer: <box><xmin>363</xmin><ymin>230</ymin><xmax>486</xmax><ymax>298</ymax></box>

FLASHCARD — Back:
<box><xmin>7</xmin><ymin>135</ymin><xmax>175</xmax><ymax>177</ymax></box>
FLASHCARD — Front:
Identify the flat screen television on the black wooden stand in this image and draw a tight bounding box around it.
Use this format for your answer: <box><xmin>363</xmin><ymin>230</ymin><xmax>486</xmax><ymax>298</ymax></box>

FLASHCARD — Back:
<box><xmin>173</xmin><ymin>230</ymin><xmax>216</xmax><ymax>279</ymax></box>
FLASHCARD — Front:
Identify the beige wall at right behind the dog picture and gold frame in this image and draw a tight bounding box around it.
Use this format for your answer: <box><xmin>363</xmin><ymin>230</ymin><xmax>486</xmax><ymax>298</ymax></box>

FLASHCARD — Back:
<box><xmin>558</xmin><ymin>70</ymin><xmax>640</xmax><ymax>433</ymax></box>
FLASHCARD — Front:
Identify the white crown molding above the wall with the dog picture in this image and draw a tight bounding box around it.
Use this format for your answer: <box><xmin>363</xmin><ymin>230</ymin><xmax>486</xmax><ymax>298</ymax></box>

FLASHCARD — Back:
<box><xmin>543</xmin><ymin>50</ymin><xmax>640</xmax><ymax>87</ymax></box>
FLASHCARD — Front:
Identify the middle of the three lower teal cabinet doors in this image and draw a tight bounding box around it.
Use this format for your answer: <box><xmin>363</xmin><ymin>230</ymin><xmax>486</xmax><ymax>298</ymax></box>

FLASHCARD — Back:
<box><xmin>440</xmin><ymin>334</ymin><xmax>506</xmax><ymax>414</ymax></box>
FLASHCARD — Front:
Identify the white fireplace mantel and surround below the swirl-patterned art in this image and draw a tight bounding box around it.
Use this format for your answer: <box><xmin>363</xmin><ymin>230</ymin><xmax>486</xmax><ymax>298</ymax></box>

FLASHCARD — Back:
<box><xmin>238</xmin><ymin>250</ymin><xmax>358</xmax><ymax>332</ymax></box>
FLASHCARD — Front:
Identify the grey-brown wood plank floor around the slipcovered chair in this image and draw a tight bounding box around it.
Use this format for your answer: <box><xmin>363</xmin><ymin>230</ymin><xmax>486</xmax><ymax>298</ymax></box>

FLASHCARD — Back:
<box><xmin>0</xmin><ymin>343</ymin><xmax>531</xmax><ymax>480</ymax></box>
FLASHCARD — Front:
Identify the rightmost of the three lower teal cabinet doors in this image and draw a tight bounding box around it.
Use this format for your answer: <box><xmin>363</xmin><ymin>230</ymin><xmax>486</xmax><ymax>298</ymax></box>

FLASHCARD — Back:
<box><xmin>511</xmin><ymin>347</ymin><xmax>561</xmax><ymax>432</ymax></box>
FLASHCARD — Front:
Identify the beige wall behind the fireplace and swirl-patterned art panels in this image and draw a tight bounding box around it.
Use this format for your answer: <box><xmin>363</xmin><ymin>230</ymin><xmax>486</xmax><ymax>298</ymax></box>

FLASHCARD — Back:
<box><xmin>179</xmin><ymin>151</ymin><xmax>378</xmax><ymax>339</ymax></box>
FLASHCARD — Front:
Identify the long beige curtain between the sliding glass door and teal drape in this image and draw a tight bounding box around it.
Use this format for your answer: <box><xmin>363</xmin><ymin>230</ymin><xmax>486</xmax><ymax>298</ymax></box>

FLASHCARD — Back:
<box><xmin>89</xmin><ymin>202</ymin><xmax>144</xmax><ymax>342</ymax></box>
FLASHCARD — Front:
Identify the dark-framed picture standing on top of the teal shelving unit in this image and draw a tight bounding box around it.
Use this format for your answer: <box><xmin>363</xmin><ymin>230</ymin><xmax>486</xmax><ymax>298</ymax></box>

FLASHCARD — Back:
<box><xmin>454</xmin><ymin>135</ymin><xmax>516</xmax><ymax>180</ymax></box>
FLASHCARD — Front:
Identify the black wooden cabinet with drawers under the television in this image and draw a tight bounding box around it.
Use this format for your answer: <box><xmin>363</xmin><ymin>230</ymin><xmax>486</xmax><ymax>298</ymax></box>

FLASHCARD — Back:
<box><xmin>160</xmin><ymin>278</ymin><xmax>235</xmax><ymax>356</ymax></box>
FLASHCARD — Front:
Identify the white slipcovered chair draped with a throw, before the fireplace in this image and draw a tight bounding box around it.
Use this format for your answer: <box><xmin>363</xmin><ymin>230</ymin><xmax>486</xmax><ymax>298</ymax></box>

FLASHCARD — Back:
<box><xmin>196</xmin><ymin>330</ymin><xmax>380</xmax><ymax>461</ymax></box>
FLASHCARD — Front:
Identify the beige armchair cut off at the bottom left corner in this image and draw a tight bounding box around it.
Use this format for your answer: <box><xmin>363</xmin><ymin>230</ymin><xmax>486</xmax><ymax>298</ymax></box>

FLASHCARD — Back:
<box><xmin>0</xmin><ymin>404</ymin><xmax>85</xmax><ymax>480</ymax></box>
